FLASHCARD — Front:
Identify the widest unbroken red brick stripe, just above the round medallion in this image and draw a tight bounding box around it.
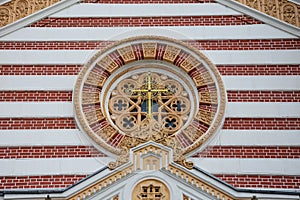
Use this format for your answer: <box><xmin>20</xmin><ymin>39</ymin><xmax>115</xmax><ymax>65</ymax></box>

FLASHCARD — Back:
<box><xmin>30</xmin><ymin>15</ymin><xmax>262</xmax><ymax>27</ymax></box>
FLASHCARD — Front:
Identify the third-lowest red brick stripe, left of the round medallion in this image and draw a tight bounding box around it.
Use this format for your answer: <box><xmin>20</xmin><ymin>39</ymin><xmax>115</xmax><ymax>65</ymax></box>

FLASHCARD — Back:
<box><xmin>0</xmin><ymin>118</ymin><xmax>76</xmax><ymax>130</ymax></box>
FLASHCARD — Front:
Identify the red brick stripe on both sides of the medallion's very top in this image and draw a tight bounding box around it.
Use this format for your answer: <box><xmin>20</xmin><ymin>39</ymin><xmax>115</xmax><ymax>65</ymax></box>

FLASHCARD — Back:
<box><xmin>0</xmin><ymin>39</ymin><xmax>300</xmax><ymax>51</ymax></box>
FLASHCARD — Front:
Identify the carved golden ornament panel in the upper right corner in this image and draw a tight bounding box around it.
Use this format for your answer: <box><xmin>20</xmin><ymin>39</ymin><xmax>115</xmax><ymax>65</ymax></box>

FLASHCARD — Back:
<box><xmin>235</xmin><ymin>0</ymin><xmax>300</xmax><ymax>27</ymax></box>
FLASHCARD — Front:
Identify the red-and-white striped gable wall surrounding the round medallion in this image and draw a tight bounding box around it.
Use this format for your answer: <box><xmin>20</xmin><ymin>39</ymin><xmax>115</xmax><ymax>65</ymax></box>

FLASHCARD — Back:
<box><xmin>0</xmin><ymin>0</ymin><xmax>300</xmax><ymax>199</ymax></box>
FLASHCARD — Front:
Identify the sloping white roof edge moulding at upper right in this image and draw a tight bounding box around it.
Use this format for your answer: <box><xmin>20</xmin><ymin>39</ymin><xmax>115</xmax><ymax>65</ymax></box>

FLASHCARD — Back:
<box><xmin>215</xmin><ymin>0</ymin><xmax>300</xmax><ymax>37</ymax></box>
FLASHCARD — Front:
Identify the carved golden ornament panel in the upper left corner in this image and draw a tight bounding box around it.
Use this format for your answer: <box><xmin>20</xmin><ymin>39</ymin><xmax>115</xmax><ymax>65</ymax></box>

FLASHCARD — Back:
<box><xmin>0</xmin><ymin>0</ymin><xmax>60</xmax><ymax>27</ymax></box>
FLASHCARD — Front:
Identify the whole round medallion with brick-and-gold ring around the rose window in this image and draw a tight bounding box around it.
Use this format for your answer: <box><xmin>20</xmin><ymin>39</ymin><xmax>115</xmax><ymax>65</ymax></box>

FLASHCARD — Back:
<box><xmin>74</xmin><ymin>36</ymin><xmax>226</xmax><ymax>166</ymax></box>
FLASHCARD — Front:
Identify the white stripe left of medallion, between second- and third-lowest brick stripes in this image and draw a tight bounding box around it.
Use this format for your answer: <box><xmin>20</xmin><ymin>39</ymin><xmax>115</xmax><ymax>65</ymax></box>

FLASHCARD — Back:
<box><xmin>0</xmin><ymin>129</ymin><xmax>92</xmax><ymax>146</ymax></box>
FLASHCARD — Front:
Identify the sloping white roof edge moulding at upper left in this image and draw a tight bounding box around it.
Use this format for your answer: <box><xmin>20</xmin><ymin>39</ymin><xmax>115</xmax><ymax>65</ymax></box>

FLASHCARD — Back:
<box><xmin>0</xmin><ymin>0</ymin><xmax>80</xmax><ymax>37</ymax></box>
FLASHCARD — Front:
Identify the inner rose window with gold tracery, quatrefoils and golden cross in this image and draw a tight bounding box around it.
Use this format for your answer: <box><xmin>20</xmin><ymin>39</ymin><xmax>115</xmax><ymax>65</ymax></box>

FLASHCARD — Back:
<box><xmin>108</xmin><ymin>72</ymin><xmax>191</xmax><ymax>139</ymax></box>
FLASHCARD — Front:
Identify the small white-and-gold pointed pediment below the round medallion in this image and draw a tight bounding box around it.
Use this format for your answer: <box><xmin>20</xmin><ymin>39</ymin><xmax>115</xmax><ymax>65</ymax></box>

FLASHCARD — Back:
<box><xmin>4</xmin><ymin>141</ymin><xmax>298</xmax><ymax>200</ymax></box>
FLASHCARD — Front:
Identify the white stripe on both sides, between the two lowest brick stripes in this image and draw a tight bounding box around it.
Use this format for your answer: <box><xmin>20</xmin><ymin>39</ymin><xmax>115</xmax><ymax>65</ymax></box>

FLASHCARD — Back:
<box><xmin>0</xmin><ymin>157</ymin><xmax>300</xmax><ymax>176</ymax></box>
